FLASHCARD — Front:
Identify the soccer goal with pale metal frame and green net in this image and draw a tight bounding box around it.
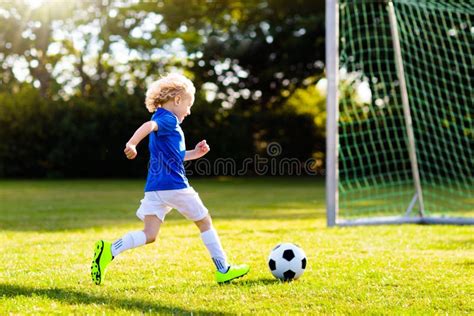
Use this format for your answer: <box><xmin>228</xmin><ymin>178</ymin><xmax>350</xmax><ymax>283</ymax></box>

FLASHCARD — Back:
<box><xmin>326</xmin><ymin>0</ymin><xmax>474</xmax><ymax>225</ymax></box>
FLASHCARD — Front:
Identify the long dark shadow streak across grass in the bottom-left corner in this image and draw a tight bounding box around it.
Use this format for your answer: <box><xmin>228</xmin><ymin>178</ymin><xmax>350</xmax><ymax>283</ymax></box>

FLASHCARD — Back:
<box><xmin>0</xmin><ymin>284</ymin><xmax>228</xmax><ymax>315</ymax></box>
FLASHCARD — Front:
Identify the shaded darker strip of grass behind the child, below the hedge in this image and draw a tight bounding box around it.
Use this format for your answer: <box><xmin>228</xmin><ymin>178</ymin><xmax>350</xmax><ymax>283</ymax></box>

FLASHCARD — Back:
<box><xmin>0</xmin><ymin>178</ymin><xmax>325</xmax><ymax>231</ymax></box>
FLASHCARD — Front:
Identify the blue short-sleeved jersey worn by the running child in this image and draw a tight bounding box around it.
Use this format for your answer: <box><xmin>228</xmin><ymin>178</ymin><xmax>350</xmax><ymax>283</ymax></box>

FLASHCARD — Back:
<box><xmin>145</xmin><ymin>108</ymin><xmax>189</xmax><ymax>192</ymax></box>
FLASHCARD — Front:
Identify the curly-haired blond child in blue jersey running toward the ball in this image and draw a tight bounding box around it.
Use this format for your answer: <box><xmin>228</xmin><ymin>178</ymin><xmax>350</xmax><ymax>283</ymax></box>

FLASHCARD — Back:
<box><xmin>91</xmin><ymin>74</ymin><xmax>249</xmax><ymax>285</ymax></box>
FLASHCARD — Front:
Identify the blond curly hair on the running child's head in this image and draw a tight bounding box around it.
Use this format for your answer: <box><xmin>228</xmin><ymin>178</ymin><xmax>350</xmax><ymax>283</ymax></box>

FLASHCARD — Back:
<box><xmin>145</xmin><ymin>73</ymin><xmax>196</xmax><ymax>113</ymax></box>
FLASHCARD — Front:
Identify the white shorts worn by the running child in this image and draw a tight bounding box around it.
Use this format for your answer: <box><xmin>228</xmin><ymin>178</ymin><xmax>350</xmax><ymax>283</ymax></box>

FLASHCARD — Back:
<box><xmin>137</xmin><ymin>187</ymin><xmax>209</xmax><ymax>222</ymax></box>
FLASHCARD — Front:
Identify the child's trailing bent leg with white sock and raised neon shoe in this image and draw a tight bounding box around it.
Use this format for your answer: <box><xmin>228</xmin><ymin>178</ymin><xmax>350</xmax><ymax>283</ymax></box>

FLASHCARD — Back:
<box><xmin>91</xmin><ymin>215</ymin><xmax>162</xmax><ymax>285</ymax></box>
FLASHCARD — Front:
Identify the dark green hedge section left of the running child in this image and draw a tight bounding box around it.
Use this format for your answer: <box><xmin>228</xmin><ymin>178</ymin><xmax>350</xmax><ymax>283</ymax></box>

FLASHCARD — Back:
<box><xmin>0</xmin><ymin>87</ymin><xmax>148</xmax><ymax>177</ymax></box>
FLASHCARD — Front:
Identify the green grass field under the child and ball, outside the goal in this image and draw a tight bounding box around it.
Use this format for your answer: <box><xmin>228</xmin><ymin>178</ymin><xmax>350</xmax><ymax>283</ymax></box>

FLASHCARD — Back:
<box><xmin>0</xmin><ymin>178</ymin><xmax>474</xmax><ymax>315</ymax></box>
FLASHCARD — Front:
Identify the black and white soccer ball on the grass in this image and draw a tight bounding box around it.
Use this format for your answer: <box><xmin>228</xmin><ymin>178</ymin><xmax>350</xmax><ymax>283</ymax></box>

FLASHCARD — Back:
<box><xmin>268</xmin><ymin>243</ymin><xmax>306</xmax><ymax>281</ymax></box>
